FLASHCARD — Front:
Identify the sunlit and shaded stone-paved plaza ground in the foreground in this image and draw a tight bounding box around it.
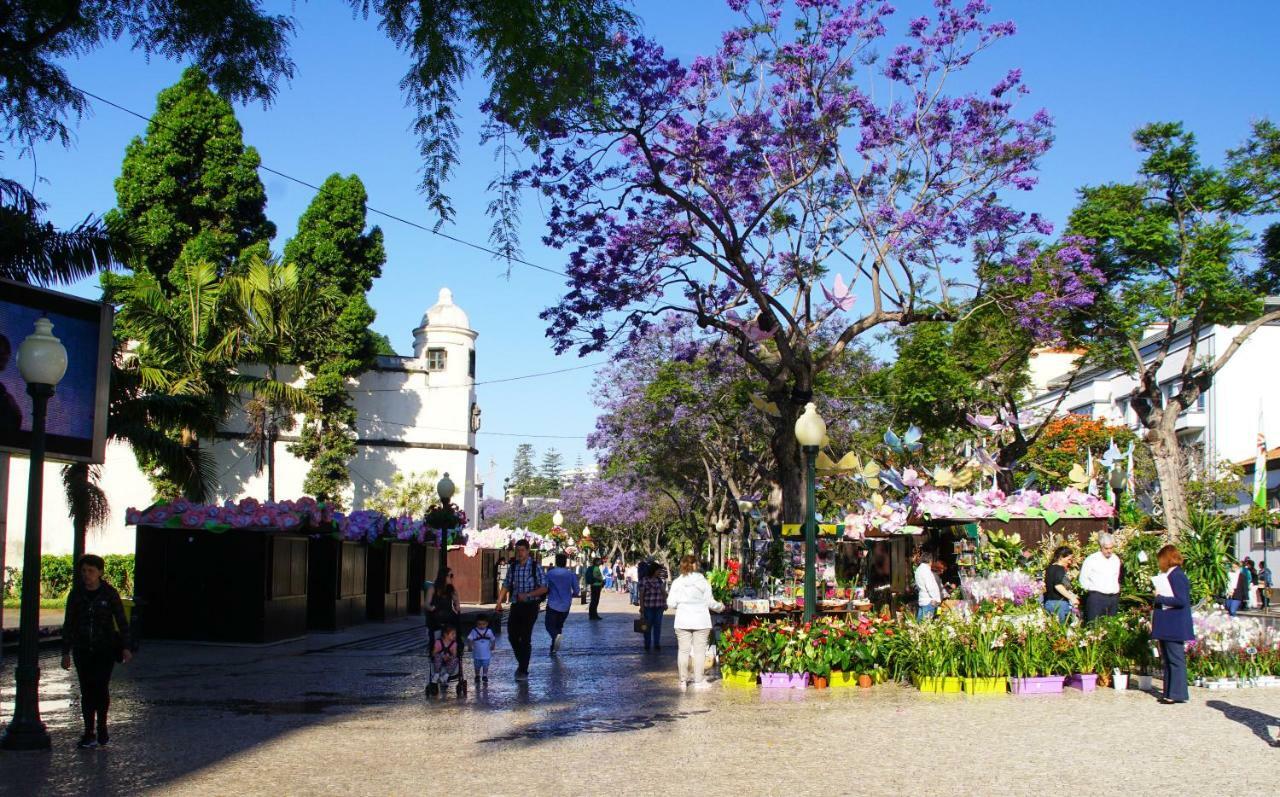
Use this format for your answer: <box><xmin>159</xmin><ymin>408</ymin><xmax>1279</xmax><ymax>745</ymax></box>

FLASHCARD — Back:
<box><xmin>0</xmin><ymin>595</ymin><xmax>1280</xmax><ymax>797</ymax></box>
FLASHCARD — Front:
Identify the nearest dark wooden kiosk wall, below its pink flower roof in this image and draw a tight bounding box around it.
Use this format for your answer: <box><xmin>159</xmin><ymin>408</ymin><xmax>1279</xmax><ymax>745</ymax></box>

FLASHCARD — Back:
<box><xmin>133</xmin><ymin>525</ymin><xmax>310</xmax><ymax>643</ymax></box>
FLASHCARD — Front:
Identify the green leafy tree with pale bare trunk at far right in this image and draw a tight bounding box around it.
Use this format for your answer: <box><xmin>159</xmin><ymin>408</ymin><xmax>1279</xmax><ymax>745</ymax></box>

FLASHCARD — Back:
<box><xmin>1068</xmin><ymin>123</ymin><xmax>1280</xmax><ymax>539</ymax></box>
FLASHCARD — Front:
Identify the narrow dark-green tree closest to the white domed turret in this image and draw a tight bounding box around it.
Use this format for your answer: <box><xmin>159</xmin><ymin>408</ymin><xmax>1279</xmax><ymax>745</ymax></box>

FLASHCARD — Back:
<box><xmin>284</xmin><ymin>174</ymin><xmax>387</xmax><ymax>501</ymax></box>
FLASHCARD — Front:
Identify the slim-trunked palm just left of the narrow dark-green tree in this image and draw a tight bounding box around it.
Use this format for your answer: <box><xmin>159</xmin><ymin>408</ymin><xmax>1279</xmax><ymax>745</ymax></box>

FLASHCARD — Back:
<box><xmin>229</xmin><ymin>260</ymin><xmax>338</xmax><ymax>500</ymax></box>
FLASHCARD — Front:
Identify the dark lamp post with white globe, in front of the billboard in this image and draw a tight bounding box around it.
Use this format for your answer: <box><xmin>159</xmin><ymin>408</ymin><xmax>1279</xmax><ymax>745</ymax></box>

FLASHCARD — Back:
<box><xmin>0</xmin><ymin>317</ymin><xmax>67</xmax><ymax>750</ymax></box>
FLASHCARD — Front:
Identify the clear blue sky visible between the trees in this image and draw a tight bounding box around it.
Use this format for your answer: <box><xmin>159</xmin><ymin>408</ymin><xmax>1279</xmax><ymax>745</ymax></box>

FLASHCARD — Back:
<box><xmin>10</xmin><ymin>0</ymin><xmax>1280</xmax><ymax>485</ymax></box>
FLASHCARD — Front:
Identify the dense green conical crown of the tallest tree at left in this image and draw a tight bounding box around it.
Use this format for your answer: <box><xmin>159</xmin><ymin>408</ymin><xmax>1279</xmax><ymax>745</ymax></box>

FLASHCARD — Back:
<box><xmin>106</xmin><ymin>68</ymin><xmax>275</xmax><ymax>294</ymax></box>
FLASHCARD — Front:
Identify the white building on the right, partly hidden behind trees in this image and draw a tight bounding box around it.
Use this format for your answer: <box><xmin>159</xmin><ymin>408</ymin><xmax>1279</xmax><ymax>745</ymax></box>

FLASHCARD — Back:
<box><xmin>1029</xmin><ymin>305</ymin><xmax>1280</xmax><ymax>571</ymax></box>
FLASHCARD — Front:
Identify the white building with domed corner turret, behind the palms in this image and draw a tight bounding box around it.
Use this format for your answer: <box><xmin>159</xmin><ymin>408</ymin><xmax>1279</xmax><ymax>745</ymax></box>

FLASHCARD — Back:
<box><xmin>0</xmin><ymin>288</ymin><xmax>481</xmax><ymax>567</ymax></box>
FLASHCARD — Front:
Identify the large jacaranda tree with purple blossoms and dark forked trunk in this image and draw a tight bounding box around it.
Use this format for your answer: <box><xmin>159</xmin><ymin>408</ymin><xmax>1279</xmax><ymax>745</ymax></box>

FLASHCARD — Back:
<box><xmin>520</xmin><ymin>0</ymin><xmax>1090</xmax><ymax>519</ymax></box>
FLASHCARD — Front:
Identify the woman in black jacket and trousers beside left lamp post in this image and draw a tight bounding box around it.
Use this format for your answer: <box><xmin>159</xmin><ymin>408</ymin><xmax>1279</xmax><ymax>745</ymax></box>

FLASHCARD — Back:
<box><xmin>63</xmin><ymin>554</ymin><xmax>136</xmax><ymax>750</ymax></box>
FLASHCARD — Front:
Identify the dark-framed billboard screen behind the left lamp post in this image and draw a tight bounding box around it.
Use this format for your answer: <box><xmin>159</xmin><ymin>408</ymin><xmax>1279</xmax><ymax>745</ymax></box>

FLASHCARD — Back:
<box><xmin>0</xmin><ymin>280</ymin><xmax>111</xmax><ymax>462</ymax></box>
